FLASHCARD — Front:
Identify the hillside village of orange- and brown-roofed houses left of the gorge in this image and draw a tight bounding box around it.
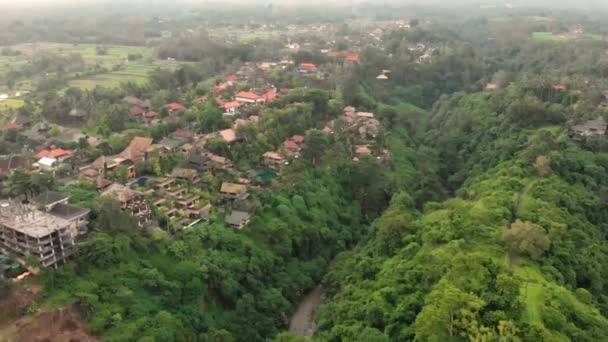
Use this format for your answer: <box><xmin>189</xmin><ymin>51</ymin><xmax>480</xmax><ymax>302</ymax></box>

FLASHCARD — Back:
<box><xmin>0</xmin><ymin>39</ymin><xmax>390</xmax><ymax>272</ymax></box>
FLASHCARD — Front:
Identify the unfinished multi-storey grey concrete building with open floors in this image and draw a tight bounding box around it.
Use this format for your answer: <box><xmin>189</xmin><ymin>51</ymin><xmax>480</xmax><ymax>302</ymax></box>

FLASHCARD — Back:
<box><xmin>0</xmin><ymin>200</ymin><xmax>74</xmax><ymax>268</ymax></box>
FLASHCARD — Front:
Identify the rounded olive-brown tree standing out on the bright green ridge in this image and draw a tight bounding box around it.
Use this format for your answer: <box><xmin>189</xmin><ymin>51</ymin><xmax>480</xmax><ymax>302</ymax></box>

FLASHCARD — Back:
<box><xmin>503</xmin><ymin>220</ymin><xmax>551</xmax><ymax>259</ymax></box>
